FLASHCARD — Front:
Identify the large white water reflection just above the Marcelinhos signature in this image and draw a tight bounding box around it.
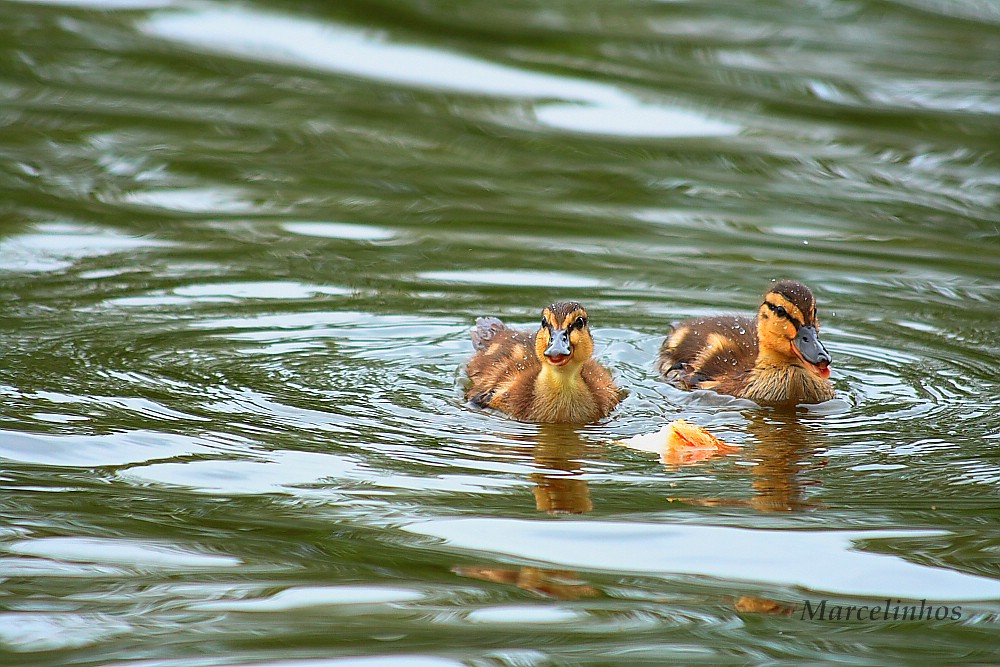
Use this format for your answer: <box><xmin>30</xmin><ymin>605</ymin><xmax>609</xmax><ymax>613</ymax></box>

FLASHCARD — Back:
<box><xmin>404</xmin><ymin>519</ymin><xmax>1000</xmax><ymax>600</ymax></box>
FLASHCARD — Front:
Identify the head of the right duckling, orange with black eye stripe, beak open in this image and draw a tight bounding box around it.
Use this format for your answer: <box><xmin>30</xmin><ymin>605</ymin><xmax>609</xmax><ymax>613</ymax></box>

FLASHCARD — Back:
<box><xmin>757</xmin><ymin>280</ymin><xmax>831</xmax><ymax>379</ymax></box>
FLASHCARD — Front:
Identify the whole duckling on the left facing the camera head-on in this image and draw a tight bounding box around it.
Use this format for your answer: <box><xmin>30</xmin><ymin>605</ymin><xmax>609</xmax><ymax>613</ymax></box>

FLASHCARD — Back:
<box><xmin>465</xmin><ymin>302</ymin><xmax>621</xmax><ymax>424</ymax></box>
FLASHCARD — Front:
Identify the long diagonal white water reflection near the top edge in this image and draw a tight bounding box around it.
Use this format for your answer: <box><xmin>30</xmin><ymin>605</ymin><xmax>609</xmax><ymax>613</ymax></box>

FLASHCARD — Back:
<box><xmin>139</xmin><ymin>9</ymin><xmax>740</xmax><ymax>137</ymax></box>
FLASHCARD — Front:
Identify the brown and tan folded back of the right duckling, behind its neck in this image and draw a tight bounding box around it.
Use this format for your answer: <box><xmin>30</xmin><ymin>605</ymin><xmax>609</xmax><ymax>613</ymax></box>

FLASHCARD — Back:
<box><xmin>659</xmin><ymin>315</ymin><xmax>757</xmax><ymax>389</ymax></box>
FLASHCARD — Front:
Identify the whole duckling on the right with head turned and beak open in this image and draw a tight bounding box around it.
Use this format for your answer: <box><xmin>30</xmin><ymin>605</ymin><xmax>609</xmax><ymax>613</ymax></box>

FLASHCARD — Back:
<box><xmin>658</xmin><ymin>280</ymin><xmax>833</xmax><ymax>405</ymax></box>
